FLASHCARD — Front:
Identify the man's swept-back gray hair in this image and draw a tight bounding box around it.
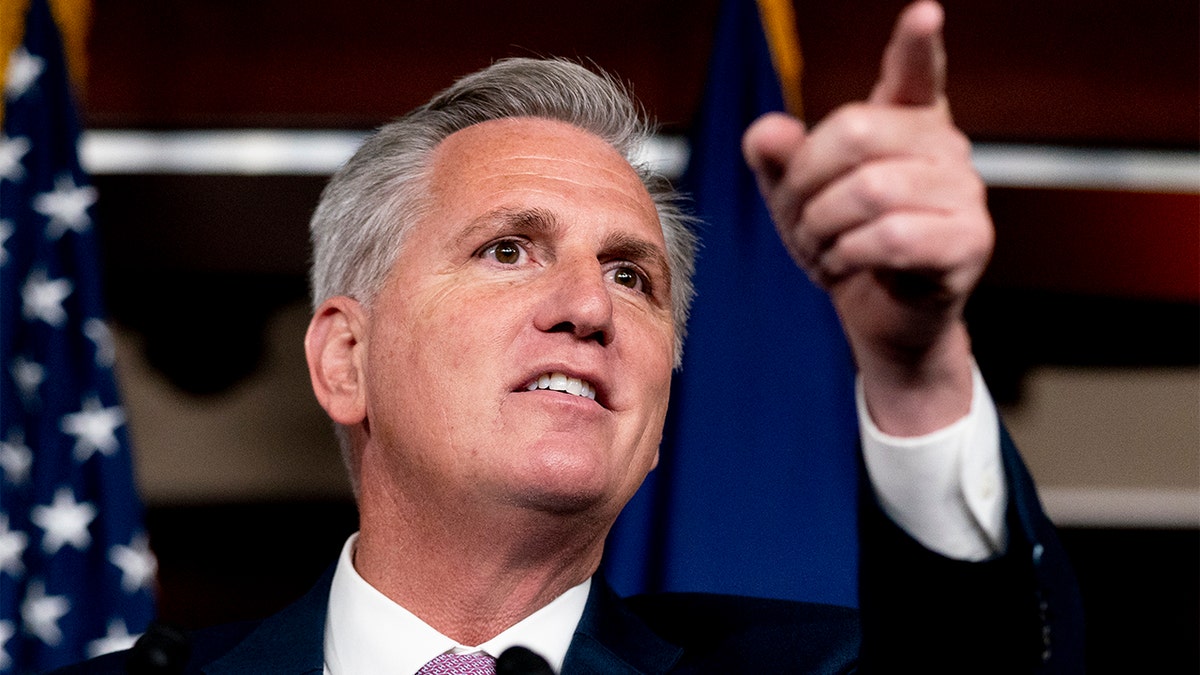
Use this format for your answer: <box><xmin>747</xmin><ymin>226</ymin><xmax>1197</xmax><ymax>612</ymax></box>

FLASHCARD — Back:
<box><xmin>310</xmin><ymin>59</ymin><xmax>697</xmax><ymax>366</ymax></box>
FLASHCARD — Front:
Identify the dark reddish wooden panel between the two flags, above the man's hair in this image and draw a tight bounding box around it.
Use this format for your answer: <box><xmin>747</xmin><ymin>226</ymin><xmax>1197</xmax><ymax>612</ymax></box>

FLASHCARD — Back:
<box><xmin>88</xmin><ymin>0</ymin><xmax>716</xmax><ymax>127</ymax></box>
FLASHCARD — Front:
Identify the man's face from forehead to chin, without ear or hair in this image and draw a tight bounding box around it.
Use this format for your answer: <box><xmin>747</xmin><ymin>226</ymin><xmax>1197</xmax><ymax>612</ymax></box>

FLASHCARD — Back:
<box><xmin>355</xmin><ymin>119</ymin><xmax>674</xmax><ymax>518</ymax></box>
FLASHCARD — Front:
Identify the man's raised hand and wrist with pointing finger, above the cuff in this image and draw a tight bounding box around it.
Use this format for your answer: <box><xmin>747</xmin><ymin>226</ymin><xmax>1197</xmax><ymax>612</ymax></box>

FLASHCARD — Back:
<box><xmin>743</xmin><ymin>1</ymin><xmax>994</xmax><ymax>435</ymax></box>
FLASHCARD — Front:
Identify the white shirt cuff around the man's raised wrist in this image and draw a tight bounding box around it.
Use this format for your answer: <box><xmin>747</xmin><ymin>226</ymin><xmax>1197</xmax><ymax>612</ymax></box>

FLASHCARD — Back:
<box><xmin>856</xmin><ymin>365</ymin><xmax>1008</xmax><ymax>561</ymax></box>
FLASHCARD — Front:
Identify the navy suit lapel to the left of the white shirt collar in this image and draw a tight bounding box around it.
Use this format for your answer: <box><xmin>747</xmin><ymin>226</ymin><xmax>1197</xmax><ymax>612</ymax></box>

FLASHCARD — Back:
<box><xmin>203</xmin><ymin>567</ymin><xmax>334</xmax><ymax>675</ymax></box>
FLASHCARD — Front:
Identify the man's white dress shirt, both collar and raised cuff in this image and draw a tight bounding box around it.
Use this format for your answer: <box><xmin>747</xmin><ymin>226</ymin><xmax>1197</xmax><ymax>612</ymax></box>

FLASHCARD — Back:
<box><xmin>324</xmin><ymin>369</ymin><xmax>1008</xmax><ymax>675</ymax></box>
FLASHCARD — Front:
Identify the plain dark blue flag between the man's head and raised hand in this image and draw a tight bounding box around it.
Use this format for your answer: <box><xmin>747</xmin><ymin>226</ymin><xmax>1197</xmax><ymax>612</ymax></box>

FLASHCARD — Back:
<box><xmin>606</xmin><ymin>0</ymin><xmax>858</xmax><ymax>605</ymax></box>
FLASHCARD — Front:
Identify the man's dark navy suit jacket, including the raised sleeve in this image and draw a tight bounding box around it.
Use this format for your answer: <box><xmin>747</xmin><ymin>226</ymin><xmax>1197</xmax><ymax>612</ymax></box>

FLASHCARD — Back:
<box><xmin>51</xmin><ymin>434</ymin><xmax>1082</xmax><ymax>675</ymax></box>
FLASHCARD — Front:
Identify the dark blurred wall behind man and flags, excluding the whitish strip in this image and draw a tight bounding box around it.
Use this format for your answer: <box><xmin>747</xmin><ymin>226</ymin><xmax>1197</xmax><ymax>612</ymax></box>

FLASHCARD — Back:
<box><xmin>83</xmin><ymin>0</ymin><xmax>1200</xmax><ymax>673</ymax></box>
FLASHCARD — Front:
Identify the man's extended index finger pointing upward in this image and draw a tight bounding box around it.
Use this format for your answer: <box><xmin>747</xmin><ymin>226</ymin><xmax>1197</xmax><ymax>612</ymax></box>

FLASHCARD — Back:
<box><xmin>870</xmin><ymin>0</ymin><xmax>946</xmax><ymax>106</ymax></box>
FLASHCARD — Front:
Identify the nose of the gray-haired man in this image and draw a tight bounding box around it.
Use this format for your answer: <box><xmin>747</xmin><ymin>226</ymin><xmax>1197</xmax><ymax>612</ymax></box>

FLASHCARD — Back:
<box><xmin>534</xmin><ymin>258</ymin><xmax>613</xmax><ymax>345</ymax></box>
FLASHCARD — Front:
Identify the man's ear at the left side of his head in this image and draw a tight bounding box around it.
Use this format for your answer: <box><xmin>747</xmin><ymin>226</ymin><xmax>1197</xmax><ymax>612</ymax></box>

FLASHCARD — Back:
<box><xmin>304</xmin><ymin>295</ymin><xmax>366</xmax><ymax>425</ymax></box>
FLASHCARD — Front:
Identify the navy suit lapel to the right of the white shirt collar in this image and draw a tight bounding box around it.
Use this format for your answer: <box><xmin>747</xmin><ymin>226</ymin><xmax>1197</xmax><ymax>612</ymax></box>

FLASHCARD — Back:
<box><xmin>562</xmin><ymin>575</ymin><xmax>683</xmax><ymax>675</ymax></box>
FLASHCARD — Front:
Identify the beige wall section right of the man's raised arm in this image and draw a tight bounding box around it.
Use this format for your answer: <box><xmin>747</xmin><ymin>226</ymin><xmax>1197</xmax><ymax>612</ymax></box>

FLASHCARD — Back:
<box><xmin>1002</xmin><ymin>368</ymin><xmax>1200</xmax><ymax>527</ymax></box>
